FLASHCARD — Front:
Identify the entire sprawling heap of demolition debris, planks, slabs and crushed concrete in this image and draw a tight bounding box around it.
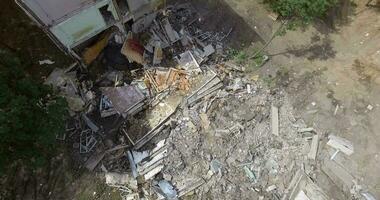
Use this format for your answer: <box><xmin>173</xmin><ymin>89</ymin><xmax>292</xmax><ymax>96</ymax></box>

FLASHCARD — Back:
<box><xmin>46</xmin><ymin>4</ymin><xmax>378</xmax><ymax>200</ymax></box>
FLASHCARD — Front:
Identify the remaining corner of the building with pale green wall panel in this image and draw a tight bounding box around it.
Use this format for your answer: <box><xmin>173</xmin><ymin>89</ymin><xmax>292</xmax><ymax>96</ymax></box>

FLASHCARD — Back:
<box><xmin>16</xmin><ymin>0</ymin><xmax>158</xmax><ymax>64</ymax></box>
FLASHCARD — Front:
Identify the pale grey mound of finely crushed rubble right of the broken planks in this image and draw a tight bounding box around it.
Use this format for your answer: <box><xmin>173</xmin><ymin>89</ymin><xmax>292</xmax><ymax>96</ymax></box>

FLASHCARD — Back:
<box><xmin>163</xmin><ymin>84</ymin><xmax>308</xmax><ymax>199</ymax></box>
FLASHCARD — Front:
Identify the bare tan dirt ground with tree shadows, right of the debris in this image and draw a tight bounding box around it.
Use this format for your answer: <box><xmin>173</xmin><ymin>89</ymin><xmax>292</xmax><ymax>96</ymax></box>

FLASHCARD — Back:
<box><xmin>226</xmin><ymin>0</ymin><xmax>380</xmax><ymax>197</ymax></box>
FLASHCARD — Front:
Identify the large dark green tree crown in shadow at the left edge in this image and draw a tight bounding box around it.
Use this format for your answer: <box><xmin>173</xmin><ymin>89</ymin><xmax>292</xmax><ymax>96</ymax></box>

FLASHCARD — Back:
<box><xmin>0</xmin><ymin>49</ymin><xmax>67</xmax><ymax>173</ymax></box>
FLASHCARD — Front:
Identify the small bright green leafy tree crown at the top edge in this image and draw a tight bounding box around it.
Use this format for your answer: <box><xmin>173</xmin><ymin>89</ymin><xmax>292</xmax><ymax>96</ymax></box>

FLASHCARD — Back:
<box><xmin>265</xmin><ymin>0</ymin><xmax>337</xmax><ymax>29</ymax></box>
